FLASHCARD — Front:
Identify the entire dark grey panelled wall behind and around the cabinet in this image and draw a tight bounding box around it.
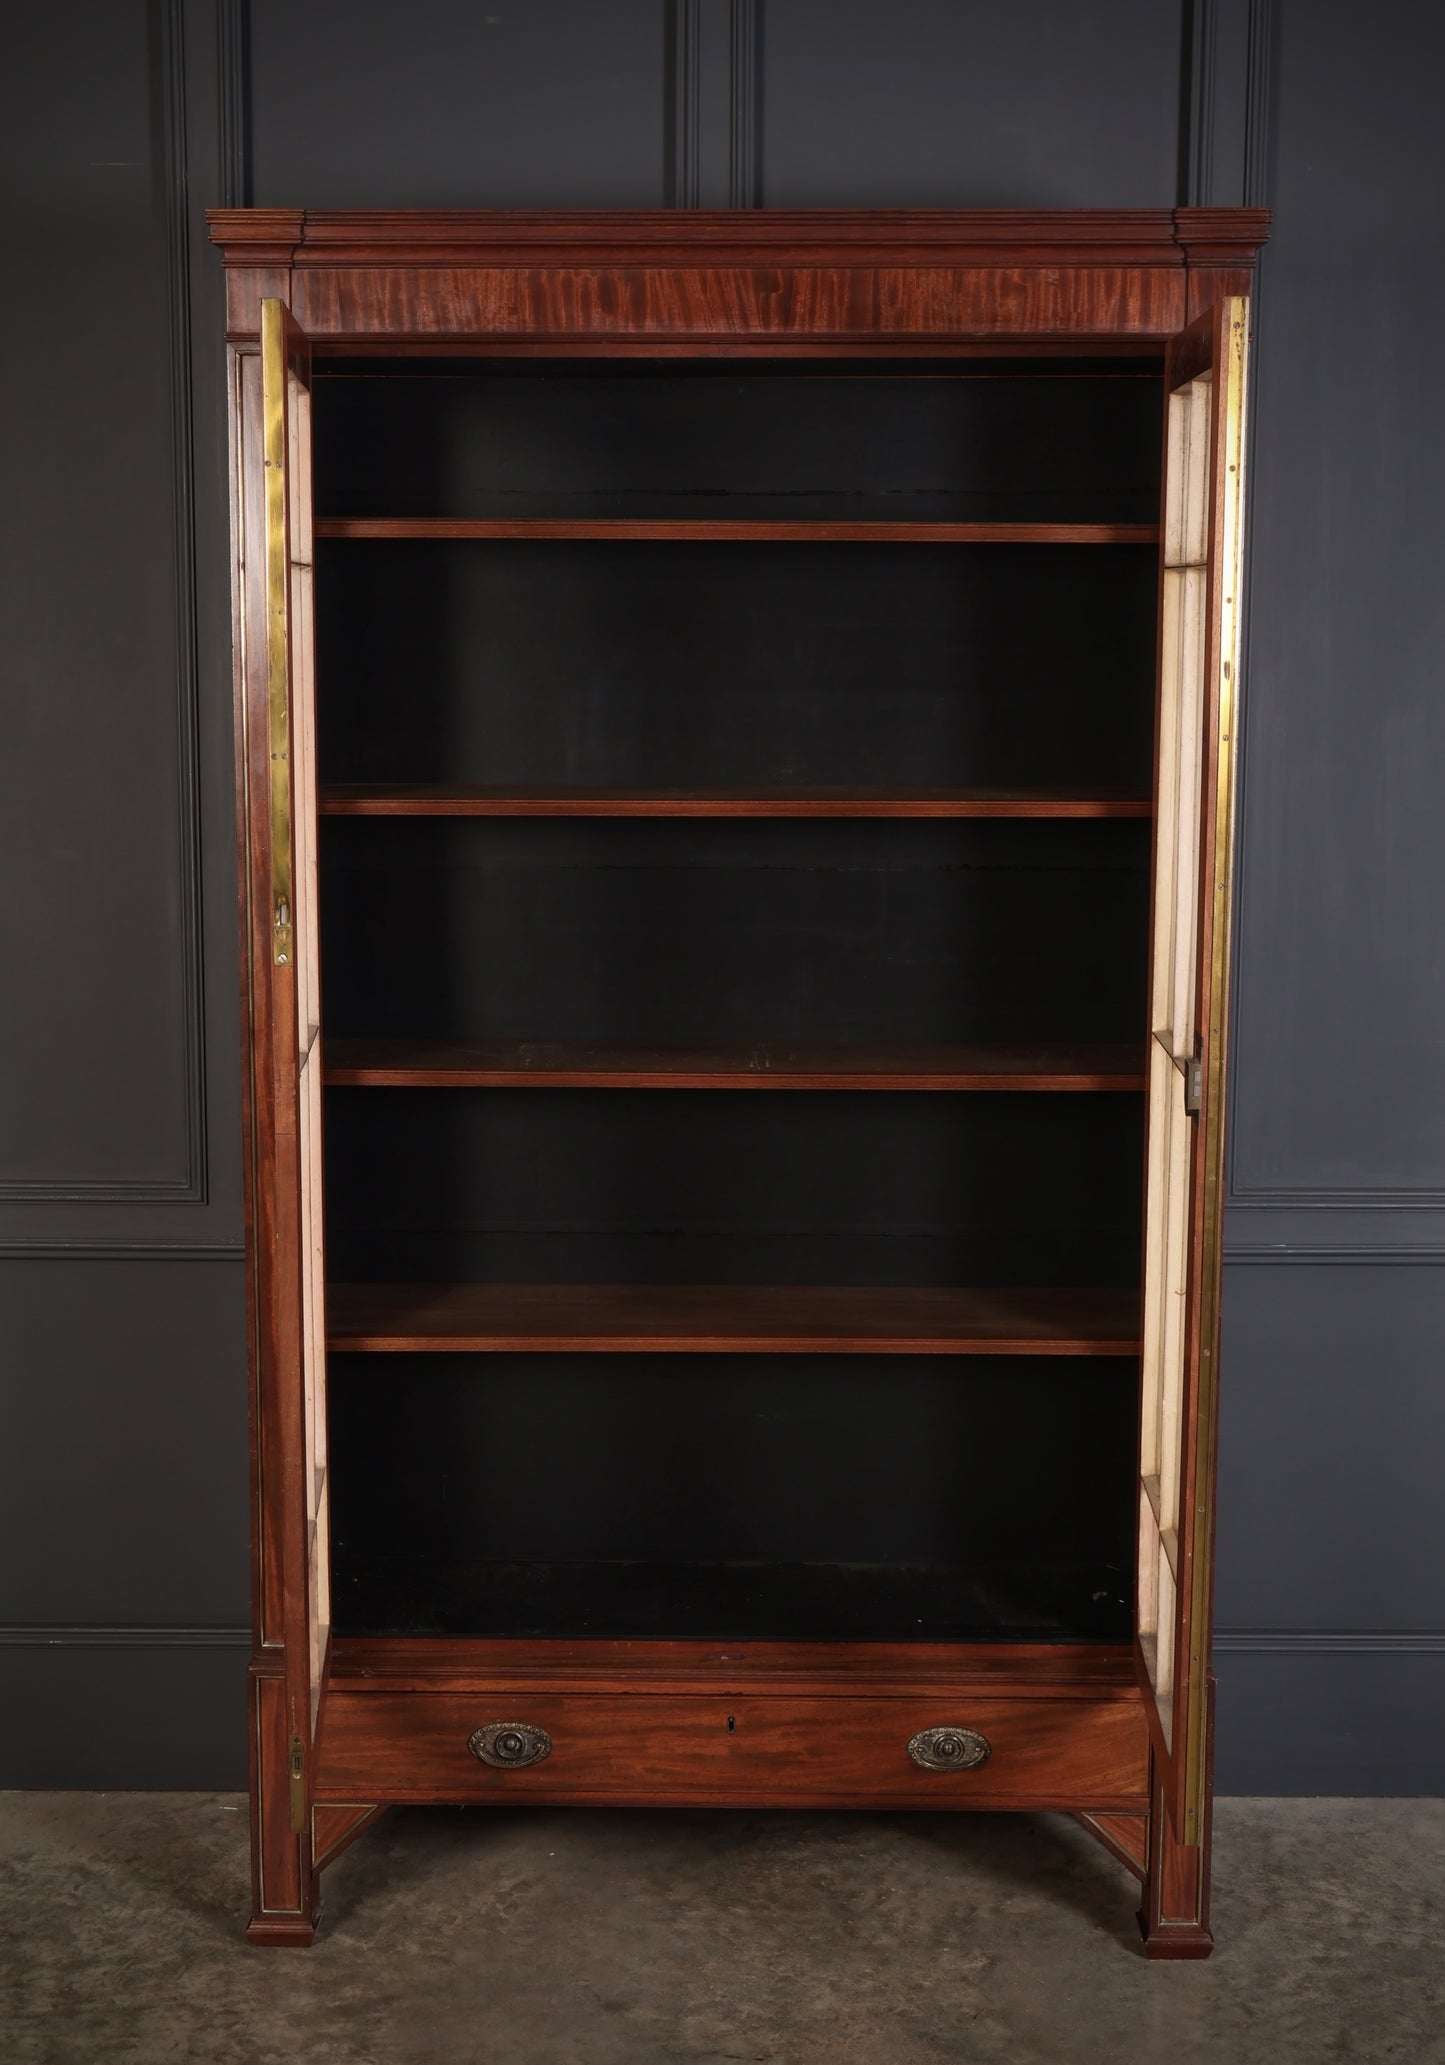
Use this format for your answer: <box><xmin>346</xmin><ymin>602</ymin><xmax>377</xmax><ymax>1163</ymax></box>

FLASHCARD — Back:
<box><xmin>0</xmin><ymin>0</ymin><xmax>1445</xmax><ymax>1792</ymax></box>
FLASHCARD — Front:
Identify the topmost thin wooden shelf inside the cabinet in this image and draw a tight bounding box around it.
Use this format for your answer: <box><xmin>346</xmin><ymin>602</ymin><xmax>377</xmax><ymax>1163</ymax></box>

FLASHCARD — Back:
<box><xmin>316</xmin><ymin>516</ymin><xmax>1158</xmax><ymax>545</ymax></box>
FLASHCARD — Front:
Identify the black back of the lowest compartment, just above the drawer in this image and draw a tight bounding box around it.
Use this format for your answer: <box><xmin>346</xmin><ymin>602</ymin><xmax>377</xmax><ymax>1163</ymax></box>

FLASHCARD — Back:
<box><xmin>330</xmin><ymin>1357</ymin><xmax>1137</xmax><ymax>1640</ymax></box>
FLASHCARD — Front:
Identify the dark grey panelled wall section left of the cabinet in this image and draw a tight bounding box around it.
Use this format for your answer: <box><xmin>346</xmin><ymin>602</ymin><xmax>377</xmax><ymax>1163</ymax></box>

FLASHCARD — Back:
<box><xmin>0</xmin><ymin>0</ymin><xmax>250</xmax><ymax>1786</ymax></box>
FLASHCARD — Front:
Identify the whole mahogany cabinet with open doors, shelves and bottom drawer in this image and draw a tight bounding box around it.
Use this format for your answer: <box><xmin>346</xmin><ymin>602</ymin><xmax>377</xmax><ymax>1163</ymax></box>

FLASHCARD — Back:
<box><xmin>211</xmin><ymin>209</ymin><xmax>1265</xmax><ymax>1956</ymax></box>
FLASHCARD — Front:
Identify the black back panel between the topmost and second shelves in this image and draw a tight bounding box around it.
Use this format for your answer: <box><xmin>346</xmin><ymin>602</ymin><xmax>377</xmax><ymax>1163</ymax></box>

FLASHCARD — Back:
<box><xmin>316</xmin><ymin>539</ymin><xmax>1158</xmax><ymax>793</ymax></box>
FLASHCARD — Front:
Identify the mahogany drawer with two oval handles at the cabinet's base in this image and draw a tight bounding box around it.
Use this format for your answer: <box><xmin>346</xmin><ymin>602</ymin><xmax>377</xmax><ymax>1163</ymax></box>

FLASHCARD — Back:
<box><xmin>316</xmin><ymin>1685</ymin><xmax>1148</xmax><ymax>1807</ymax></box>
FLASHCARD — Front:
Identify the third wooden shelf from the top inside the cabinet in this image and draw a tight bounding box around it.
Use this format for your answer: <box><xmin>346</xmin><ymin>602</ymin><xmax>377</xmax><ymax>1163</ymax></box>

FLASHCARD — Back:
<box><xmin>324</xmin><ymin>1039</ymin><xmax>1144</xmax><ymax>1090</ymax></box>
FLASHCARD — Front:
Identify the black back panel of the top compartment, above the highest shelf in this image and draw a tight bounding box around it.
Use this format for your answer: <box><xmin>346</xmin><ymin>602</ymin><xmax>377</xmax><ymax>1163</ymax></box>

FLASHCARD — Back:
<box><xmin>316</xmin><ymin>363</ymin><xmax>1160</xmax><ymax>522</ymax></box>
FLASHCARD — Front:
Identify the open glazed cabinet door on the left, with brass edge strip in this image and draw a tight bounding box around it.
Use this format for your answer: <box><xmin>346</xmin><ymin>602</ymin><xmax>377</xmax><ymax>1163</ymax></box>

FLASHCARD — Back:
<box><xmin>233</xmin><ymin>297</ymin><xmax>330</xmax><ymax>1899</ymax></box>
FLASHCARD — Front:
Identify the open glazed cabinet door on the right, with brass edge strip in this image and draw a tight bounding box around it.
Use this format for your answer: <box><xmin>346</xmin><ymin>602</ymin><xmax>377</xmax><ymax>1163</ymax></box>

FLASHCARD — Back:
<box><xmin>1137</xmin><ymin>297</ymin><xmax>1249</xmax><ymax>1846</ymax></box>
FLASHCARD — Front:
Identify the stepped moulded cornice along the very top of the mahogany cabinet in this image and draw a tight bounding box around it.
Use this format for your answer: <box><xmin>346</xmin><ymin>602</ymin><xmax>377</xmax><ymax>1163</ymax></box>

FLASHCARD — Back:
<box><xmin>206</xmin><ymin>209</ymin><xmax>1270</xmax><ymax>266</ymax></box>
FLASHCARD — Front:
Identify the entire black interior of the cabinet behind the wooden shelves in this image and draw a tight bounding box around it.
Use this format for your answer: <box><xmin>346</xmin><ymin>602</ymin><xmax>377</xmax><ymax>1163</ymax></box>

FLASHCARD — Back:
<box><xmin>312</xmin><ymin>359</ymin><xmax>1160</xmax><ymax>1642</ymax></box>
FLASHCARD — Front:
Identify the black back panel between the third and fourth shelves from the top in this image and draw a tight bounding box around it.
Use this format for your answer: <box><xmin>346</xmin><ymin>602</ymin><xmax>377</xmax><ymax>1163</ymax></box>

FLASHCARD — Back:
<box><xmin>326</xmin><ymin>1088</ymin><xmax>1142</xmax><ymax>1284</ymax></box>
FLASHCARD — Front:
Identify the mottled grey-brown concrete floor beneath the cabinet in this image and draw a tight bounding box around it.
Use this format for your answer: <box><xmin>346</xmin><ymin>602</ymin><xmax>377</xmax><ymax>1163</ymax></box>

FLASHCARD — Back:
<box><xmin>0</xmin><ymin>1792</ymin><xmax>1445</xmax><ymax>2065</ymax></box>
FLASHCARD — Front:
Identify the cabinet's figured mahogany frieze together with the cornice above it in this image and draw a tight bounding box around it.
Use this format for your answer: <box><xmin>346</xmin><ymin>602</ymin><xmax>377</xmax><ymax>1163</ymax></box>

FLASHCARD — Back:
<box><xmin>211</xmin><ymin>209</ymin><xmax>1263</xmax><ymax>351</ymax></box>
